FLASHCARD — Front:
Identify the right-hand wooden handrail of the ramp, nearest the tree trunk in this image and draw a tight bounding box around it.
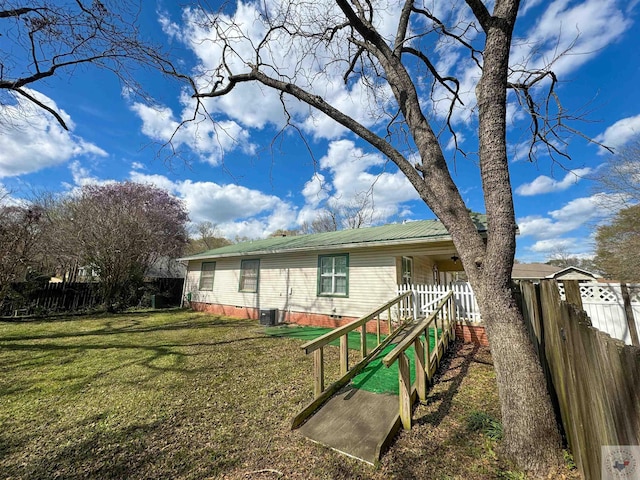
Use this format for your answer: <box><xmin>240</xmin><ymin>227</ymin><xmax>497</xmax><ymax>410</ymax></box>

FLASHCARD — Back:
<box><xmin>382</xmin><ymin>292</ymin><xmax>455</xmax><ymax>430</ymax></box>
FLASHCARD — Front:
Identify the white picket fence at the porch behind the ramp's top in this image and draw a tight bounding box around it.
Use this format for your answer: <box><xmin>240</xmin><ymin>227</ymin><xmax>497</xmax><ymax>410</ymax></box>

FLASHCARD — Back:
<box><xmin>398</xmin><ymin>283</ymin><xmax>481</xmax><ymax>322</ymax></box>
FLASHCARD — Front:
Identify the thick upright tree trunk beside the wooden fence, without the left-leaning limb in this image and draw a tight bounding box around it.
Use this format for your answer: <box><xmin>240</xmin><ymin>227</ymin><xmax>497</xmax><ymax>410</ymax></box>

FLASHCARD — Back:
<box><xmin>454</xmin><ymin>0</ymin><xmax>561</xmax><ymax>476</ymax></box>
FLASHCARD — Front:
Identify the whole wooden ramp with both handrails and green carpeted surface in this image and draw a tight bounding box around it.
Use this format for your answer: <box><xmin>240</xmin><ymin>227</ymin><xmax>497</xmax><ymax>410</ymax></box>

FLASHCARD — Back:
<box><xmin>292</xmin><ymin>292</ymin><xmax>455</xmax><ymax>465</ymax></box>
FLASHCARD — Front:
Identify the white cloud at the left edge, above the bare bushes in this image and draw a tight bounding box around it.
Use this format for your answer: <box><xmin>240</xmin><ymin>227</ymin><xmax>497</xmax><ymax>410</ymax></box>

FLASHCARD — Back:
<box><xmin>0</xmin><ymin>89</ymin><xmax>107</xmax><ymax>178</ymax></box>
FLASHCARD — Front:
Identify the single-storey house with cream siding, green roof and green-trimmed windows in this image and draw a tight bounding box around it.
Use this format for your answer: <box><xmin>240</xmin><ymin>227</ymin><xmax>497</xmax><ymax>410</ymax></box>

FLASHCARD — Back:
<box><xmin>180</xmin><ymin>218</ymin><xmax>486</xmax><ymax>326</ymax></box>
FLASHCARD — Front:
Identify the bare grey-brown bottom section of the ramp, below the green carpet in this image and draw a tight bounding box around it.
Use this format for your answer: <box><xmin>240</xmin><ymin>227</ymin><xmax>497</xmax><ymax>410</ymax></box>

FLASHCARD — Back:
<box><xmin>300</xmin><ymin>386</ymin><xmax>400</xmax><ymax>465</ymax></box>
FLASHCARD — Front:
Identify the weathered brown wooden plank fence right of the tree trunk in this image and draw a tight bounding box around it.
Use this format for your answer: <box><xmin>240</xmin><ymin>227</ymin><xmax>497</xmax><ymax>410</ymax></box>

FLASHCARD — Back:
<box><xmin>520</xmin><ymin>280</ymin><xmax>640</xmax><ymax>480</ymax></box>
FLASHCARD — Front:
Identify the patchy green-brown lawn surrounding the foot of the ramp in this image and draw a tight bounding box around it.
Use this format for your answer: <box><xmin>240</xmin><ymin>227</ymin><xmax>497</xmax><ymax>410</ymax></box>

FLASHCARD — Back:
<box><xmin>0</xmin><ymin>311</ymin><xmax>576</xmax><ymax>479</ymax></box>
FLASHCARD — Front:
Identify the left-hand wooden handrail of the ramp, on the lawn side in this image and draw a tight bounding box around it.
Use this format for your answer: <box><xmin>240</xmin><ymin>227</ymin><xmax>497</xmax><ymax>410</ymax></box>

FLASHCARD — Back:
<box><xmin>292</xmin><ymin>292</ymin><xmax>416</xmax><ymax>428</ymax></box>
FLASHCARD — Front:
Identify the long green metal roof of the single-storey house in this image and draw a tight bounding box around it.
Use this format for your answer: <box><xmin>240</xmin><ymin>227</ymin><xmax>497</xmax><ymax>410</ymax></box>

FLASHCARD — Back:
<box><xmin>179</xmin><ymin>214</ymin><xmax>487</xmax><ymax>260</ymax></box>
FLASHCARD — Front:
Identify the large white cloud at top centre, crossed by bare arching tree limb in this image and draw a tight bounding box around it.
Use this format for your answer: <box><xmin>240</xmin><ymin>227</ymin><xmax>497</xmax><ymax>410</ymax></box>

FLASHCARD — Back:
<box><xmin>160</xmin><ymin>0</ymin><xmax>400</xmax><ymax>144</ymax></box>
